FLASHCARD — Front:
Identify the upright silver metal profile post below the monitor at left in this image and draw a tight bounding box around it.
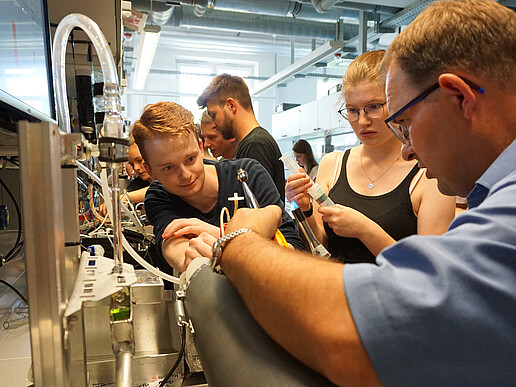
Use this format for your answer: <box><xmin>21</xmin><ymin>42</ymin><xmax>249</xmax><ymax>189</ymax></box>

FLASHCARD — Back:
<box><xmin>18</xmin><ymin>121</ymin><xmax>86</xmax><ymax>387</ymax></box>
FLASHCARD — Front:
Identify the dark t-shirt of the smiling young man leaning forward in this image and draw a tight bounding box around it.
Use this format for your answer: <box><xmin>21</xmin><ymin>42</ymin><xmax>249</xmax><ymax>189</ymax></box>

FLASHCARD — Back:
<box><xmin>145</xmin><ymin>159</ymin><xmax>304</xmax><ymax>266</ymax></box>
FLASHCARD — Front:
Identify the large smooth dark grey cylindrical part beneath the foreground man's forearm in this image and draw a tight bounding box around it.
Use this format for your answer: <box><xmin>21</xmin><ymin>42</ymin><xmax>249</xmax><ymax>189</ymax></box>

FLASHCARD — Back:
<box><xmin>185</xmin><ymin>265</ymin><xmax>333</xmax><ymax>387</ymax></box>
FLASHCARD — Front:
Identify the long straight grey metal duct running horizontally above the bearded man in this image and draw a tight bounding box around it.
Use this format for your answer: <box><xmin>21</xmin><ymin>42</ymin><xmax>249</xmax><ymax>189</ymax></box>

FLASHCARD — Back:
<box><xmin>167</xmin><ymin>6</ymin><xmax>358</xmax><ymax>40</ymax></box>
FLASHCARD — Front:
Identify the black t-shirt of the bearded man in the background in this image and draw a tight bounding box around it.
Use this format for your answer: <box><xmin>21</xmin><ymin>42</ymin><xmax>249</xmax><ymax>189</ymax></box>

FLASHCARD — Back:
<box><xmin>234</xmin><ymin>126</ymin><xmax>285</xmax><ymax>201</ymax></box>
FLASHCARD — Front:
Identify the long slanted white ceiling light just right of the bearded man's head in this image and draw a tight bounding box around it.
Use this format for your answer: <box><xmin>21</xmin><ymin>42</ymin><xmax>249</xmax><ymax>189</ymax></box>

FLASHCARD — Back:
<box><xmin>251</xmin><ymin>40</ymin><xmax>344</xmax><ymax>95</ymax></box>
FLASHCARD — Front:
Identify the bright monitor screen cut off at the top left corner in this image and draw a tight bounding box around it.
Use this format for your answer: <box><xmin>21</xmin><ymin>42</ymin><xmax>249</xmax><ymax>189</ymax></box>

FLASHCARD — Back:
<box><xmin>0</xmin><ymin>0</ymin><xmax>55</xmax><ymax>118</ymax></box>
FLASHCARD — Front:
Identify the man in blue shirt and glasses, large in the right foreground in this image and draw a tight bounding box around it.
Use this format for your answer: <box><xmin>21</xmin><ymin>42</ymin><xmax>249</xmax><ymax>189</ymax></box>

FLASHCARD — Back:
<box><xmin>189</xmin><ymin>0</ymin><xmax>516</xmax><ymax>386</ymax></box>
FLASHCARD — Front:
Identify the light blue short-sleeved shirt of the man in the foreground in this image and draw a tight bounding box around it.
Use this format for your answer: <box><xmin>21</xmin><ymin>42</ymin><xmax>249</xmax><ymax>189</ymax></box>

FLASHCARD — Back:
<box><xmin>343</xmin><ymin>141</ymin><xmax>516</xmax><ymax>387</ymax></box>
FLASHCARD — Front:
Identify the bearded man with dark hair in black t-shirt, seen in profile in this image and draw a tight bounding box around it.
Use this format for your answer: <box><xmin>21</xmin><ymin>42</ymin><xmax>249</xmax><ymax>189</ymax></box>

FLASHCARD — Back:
<box><xmin>197</xmin><ymin>74</ymin><xmax>285</xmax><ymax>201</ymax></box>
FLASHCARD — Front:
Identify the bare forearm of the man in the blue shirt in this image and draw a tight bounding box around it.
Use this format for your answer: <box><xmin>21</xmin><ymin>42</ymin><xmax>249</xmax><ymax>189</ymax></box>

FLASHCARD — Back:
<box><xmin>221</xmin><ymin>211</ymin><xmax>380</xmax><ymax>386</ymax></box>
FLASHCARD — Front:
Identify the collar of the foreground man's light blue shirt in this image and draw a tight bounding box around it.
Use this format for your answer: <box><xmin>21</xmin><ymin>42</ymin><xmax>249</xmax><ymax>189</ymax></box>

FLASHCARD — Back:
<box><xmin>467</xmin><ymin>140</ymin><xmax>516</xmax><ymax>208</ymax></box>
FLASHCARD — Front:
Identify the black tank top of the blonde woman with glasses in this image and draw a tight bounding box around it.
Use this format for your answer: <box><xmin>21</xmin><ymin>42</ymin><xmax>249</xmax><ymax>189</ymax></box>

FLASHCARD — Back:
<box><xmin>324</xmin><ymin>149</ymin><xmax>419</xmax><ymax>263</ymax></box>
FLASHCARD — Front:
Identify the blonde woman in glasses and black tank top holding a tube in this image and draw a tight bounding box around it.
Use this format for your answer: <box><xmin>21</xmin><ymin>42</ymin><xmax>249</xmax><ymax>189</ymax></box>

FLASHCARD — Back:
<box><xmin>286</xmin><ymin>51</ymin><xmax>455</xmax><ymax>263</ymax></box>
